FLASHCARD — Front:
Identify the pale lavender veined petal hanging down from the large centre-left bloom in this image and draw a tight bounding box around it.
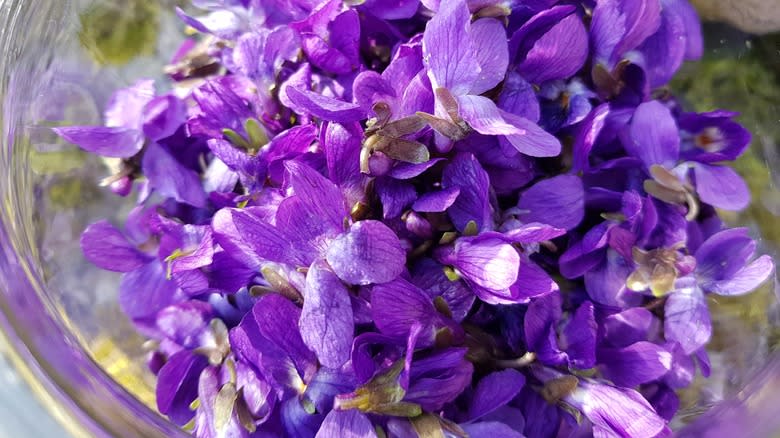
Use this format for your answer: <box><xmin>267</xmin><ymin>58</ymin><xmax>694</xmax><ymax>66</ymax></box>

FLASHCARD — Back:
<box><xmin>298</xmin><ymin>263</ymin><xmax>355</xmax><ymax>368</ymax></box>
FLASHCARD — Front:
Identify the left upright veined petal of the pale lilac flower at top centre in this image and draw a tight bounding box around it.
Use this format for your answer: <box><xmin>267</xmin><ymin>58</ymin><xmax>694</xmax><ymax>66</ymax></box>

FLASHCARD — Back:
<box><xmin>423</xmin><ymin>0</ymin><xmax>480</xmax><ymax>96</ymax></box>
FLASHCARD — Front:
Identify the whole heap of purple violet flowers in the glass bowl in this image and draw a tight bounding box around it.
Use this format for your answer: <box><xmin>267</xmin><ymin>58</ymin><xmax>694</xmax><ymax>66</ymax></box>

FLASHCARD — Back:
<box><xmin>56</xmin><ymin>0</ymin><xmax>774</xmax><ymax>438</ymax></box>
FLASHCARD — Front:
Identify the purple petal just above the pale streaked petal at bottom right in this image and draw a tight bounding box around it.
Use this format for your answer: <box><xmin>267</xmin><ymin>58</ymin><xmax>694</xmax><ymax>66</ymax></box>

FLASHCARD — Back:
<box><xmin>598</xmin><ymin>341</ymin><xmax>672</xmax><ymax>388</ymax></box>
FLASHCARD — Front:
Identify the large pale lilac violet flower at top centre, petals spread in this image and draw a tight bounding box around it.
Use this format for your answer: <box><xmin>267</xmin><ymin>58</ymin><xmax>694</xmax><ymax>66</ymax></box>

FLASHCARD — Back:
<box><xmin>423</xmin><ymin>0</ymin><xmax>560</xmax><ymax>156</ymax></box>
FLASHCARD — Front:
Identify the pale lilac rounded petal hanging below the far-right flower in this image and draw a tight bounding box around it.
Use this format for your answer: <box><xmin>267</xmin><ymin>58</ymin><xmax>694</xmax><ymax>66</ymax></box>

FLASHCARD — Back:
<box><xmin>664</xmin><ymin>287</ymin><xmax>712</xmax><ymax>354</ymax></box>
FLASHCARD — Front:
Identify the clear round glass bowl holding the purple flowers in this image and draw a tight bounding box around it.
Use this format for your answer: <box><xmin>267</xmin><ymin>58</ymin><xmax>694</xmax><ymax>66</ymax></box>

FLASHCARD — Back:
<box><xmin>0</xmin><ymin>0</ymin><xmax>780</xmax><ymax>437</ymax></box>
